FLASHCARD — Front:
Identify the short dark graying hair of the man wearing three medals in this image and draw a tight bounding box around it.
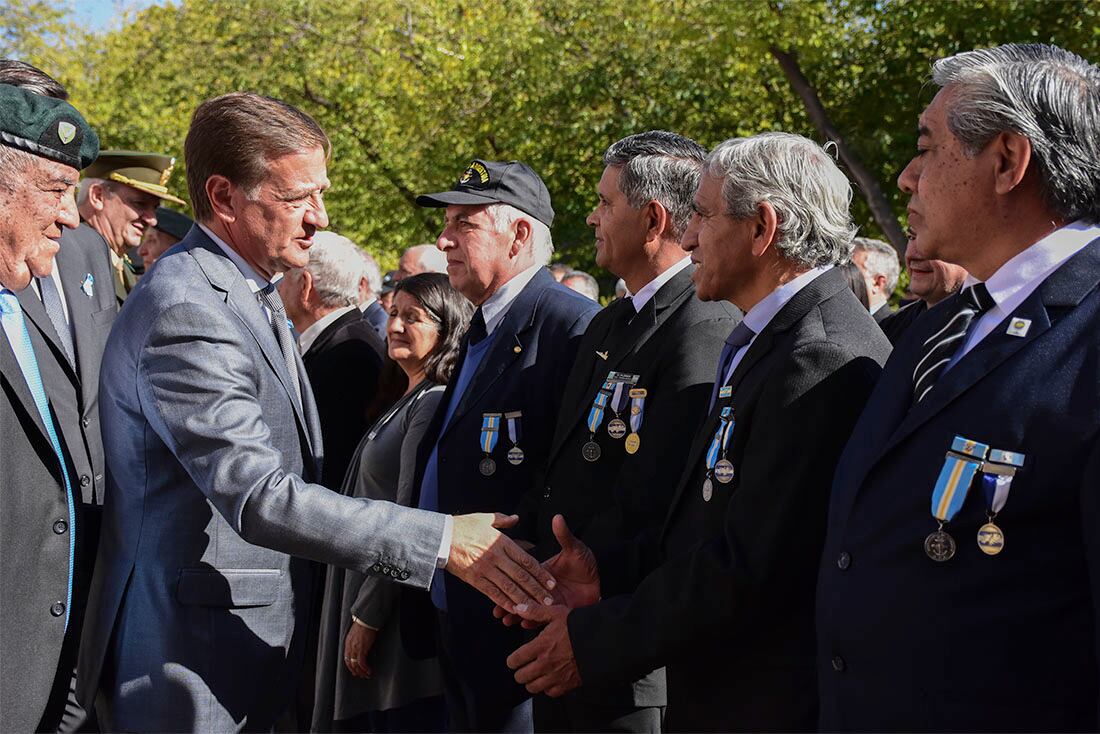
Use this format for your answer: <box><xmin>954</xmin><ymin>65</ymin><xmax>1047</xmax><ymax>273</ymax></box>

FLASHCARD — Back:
<box><xmin>604</xmin><ymin>130</ymin><xmax>706</xmax><ymax>239</ymax></box>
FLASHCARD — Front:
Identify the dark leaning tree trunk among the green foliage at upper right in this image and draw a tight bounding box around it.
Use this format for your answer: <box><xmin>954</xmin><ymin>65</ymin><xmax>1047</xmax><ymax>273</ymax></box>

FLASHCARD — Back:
<box><xmin>769</xmin><ymin>46</ymin><xmax>905</xmax><ymax>259</ymax></box>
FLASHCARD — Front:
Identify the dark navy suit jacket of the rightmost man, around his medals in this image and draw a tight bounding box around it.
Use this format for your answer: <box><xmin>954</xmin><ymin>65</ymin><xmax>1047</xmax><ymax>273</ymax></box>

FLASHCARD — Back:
<box><xmin>817</xmin><ymin>240</ymin><xmax>1100</xmax><ymax>731</ymax></box>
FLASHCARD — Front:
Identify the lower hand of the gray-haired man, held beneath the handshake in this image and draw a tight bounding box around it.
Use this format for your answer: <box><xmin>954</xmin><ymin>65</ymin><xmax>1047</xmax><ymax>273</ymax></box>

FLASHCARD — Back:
<box><xmin>507</xmin><ymin>604</ymin><xmax>581</xmax><ymax>698</ymax></box>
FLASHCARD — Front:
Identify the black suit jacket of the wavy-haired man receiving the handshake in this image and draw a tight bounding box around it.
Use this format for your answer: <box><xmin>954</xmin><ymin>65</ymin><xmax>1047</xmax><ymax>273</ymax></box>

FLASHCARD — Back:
<box><xmin>569</xmin><ymin>270</ymin><xmax>890</xmax><ymax>731</ymax></box>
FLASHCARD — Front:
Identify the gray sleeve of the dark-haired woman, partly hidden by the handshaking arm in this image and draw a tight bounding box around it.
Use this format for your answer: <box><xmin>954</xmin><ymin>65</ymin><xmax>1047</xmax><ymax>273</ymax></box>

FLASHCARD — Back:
<box><xmin>351</xmin><ymin>387</ymin><xmax>443</xmax><ymax>629</ymax></box>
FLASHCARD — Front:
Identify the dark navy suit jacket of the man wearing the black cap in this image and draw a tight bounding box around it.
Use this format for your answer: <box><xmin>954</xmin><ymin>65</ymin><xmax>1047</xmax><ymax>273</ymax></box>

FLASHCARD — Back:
<box><xmin>405</xmin><ymin>269</ymin><xmax>600</xmax><ymax>706</ymax></box>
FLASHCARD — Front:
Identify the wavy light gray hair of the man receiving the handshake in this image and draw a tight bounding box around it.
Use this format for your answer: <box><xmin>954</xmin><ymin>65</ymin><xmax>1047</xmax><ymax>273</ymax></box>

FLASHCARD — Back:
<box><xmin>706</xmin><ymin>132</ymin><xmax>856</xmax><ymax>267</ymax></box>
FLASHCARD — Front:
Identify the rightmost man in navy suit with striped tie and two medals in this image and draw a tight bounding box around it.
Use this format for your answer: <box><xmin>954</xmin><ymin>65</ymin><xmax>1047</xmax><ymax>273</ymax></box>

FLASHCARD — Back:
<box><xmin>817</xmin><ymin>44</ymin><xmax>1100</xmax><ymax>732</ymax></box>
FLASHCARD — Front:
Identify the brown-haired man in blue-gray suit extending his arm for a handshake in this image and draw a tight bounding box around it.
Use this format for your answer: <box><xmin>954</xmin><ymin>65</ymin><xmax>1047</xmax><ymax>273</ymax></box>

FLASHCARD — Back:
<box><xmin>78</xmin><ymin>92</ymin><xmax>553</xmax><ymax>732</ymax></box>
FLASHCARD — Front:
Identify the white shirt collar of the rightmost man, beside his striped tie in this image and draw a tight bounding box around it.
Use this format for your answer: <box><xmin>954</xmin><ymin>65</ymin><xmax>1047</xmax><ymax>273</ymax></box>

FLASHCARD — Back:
<box><xmin>945</xmin><ymin>219</ymin><xmax>1100</xmax><ymax>371</ymax></box>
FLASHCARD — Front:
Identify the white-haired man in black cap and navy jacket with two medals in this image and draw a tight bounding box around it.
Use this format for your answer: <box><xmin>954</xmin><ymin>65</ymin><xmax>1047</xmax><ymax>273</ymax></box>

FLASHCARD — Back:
<box><xmin>403</xmin><ymin>160</ymin><xmax>600</xmax><ymax>732</ymax></box>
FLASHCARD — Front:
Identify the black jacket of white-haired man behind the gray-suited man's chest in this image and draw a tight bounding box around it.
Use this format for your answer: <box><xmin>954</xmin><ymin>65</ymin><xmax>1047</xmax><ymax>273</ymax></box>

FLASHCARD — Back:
<box><xmin>301</xmin><ymin>308</ymin><xmax>386</xmax><ymax>491</ymax></box>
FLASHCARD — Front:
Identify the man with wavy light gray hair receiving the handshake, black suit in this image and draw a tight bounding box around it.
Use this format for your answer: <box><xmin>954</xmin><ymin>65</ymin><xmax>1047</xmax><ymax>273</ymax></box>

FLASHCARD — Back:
<box><xmin>508</xmin><ymin>133</ymin><xmax>890</xmax><ymax>732</ymax></box>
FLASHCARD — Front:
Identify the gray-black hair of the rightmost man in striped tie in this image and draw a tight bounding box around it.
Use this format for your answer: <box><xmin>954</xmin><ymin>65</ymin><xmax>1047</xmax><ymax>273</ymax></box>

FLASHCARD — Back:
<box><xmin>932</xmin><ymin>43</ymin><xmax>1100</xmax><ymax>222</ymax></box>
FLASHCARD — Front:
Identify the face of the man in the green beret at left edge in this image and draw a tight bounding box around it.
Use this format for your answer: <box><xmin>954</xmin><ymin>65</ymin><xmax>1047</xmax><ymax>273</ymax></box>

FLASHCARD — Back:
<box><xmin>0</xmin><ymin>156</ymin><xmax>80</xmax><ymax>291</ymax></box>
